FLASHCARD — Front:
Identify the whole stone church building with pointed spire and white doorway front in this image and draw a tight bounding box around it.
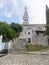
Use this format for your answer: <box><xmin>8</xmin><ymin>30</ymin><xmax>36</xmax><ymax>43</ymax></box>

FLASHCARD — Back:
<box><xmin>19</xmin><ymin>7</ymin><xmax>48</xmax><ymax>46</ymax></box>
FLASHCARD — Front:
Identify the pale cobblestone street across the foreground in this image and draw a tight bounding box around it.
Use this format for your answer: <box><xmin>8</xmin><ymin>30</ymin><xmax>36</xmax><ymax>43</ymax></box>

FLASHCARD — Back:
<box><xmin>0</xmin><ymin>53</ymin><xmax>49</xmax><ymax>65</ymax></box>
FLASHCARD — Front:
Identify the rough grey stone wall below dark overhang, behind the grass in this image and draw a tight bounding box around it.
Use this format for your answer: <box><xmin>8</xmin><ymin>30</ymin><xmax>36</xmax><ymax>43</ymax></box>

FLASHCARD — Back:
<box><xmin>32</xmin><ymin>34</ymin><xmax>48</xmax><ymax>46</ymax></box>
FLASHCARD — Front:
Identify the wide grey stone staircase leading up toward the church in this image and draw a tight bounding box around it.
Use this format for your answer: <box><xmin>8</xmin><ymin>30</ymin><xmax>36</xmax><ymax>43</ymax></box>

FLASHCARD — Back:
<box><xmin>8</xmin><ymin>39</ymin><xmax>27</xmax><ymax>54</ymax></box>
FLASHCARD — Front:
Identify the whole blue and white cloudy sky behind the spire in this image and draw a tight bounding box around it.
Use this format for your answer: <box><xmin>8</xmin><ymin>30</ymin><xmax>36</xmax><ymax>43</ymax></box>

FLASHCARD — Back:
<box><xmin>0</xmin><ymin>0</ymin><xmax>49</xmax><ymax>24</ymax></box>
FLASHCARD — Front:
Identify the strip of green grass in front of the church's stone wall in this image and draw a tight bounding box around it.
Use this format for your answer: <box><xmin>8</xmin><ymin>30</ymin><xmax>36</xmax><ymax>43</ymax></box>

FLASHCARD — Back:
<box><xmin>28</xmin><ymin>45</ymin><xmax>49</xmax><ymax>51</ymax></box>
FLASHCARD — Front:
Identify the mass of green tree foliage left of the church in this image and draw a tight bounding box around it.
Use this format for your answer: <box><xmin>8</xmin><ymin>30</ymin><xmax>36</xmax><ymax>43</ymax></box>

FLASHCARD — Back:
<box><xmin>0</xmin><ymin>22</ymin><xmax>21</xmax><ymax>42</ymax></box>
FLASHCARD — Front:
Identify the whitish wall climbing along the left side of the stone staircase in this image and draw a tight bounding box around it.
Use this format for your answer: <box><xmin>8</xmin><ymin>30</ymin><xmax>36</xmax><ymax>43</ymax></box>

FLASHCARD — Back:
<box><xmin>0</xmin><ymin>36</ymin><xmax>18</xmax><ymax>52</ymax></box>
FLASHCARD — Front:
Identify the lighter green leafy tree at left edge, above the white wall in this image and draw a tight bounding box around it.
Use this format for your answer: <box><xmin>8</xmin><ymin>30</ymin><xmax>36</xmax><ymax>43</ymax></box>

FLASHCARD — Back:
<box><xmin>0</xmin><ymin>22</ymin><xmax>16</xmax><ymax>42</ymax></box>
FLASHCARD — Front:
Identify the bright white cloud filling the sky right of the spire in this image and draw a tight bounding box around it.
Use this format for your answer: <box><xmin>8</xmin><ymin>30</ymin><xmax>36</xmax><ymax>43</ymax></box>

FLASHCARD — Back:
<box><xmin>21</xmin><ymin>0</ymin><xmax>46</xmax><ymax>23</ymax></box>
